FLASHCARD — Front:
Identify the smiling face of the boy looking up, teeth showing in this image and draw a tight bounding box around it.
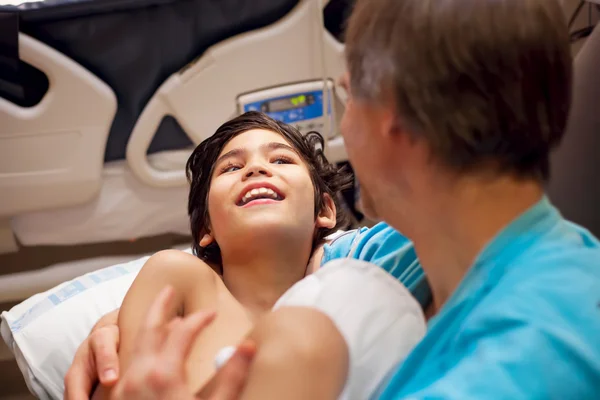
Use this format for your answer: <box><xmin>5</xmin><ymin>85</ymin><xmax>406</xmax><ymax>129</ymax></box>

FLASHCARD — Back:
<box><xmin>201</xmin><ymin>129</ymin><xmax>335</xmax><ymax>253</ymax></box>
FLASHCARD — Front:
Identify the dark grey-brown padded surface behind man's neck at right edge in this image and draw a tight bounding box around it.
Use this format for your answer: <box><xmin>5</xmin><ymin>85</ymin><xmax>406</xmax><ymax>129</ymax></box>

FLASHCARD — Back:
<box><xmin>548</xmin><ymin>25</ymin><xmax>600</xmax><ymax>237</ymax></box>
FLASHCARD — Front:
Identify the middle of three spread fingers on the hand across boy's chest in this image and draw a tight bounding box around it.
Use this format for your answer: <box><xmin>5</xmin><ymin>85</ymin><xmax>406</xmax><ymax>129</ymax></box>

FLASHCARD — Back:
<box><xmin>165</xmin><ymin>311</ymin><xmax>216</xmax><ymax>368</ymax></box>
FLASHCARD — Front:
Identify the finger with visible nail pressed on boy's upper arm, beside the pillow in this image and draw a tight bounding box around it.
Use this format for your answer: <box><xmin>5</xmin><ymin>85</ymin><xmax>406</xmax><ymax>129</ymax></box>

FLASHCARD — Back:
<box><xmin>90</xmin><ymin>325</ymin><xmax>119</xmax><ymax>386</ymax></box>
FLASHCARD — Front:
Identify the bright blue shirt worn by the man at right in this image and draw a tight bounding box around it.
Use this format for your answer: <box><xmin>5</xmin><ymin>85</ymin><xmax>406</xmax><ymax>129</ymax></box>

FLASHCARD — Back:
<box><xmin>379</xmin><ymin>198</ymin><xmax>600</xmax><ymax>400</ymax></box>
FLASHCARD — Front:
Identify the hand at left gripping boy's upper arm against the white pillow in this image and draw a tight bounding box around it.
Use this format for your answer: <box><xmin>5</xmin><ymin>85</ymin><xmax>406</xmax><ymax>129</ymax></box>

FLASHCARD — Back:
<box><xmin>64</xmin><ymin>310</ymin><xmax>119</xmax><ymax>400</ymax></box>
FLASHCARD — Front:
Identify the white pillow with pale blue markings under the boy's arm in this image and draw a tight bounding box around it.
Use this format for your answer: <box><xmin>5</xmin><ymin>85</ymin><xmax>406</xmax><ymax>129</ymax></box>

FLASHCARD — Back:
<box><xmin>0</xmin><ymin>249</ymin><xmax>191</xmax><ymax>399</ymax></box>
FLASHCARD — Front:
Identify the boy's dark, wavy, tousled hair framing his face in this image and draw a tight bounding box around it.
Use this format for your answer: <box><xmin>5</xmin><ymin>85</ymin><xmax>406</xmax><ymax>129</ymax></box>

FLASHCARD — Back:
<box><xmin>186</xmin><ymin>111</ymin><xmax>352</xmax><ymax>272</ymax></box>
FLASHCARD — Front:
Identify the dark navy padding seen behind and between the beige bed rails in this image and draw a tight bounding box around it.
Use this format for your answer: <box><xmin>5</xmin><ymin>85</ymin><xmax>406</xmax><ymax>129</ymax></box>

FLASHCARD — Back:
<box><xmin>0</xmin><ymin>0</ymin><xmax>299</xmax><ymax>161</ymax></box>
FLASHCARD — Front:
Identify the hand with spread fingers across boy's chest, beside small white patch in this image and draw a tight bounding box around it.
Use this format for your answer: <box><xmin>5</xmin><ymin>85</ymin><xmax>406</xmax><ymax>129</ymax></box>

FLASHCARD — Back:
<box><xmin>112</xmin><ymin>287</ymin><xmax>255</xmax><ymax>400</ymax></box>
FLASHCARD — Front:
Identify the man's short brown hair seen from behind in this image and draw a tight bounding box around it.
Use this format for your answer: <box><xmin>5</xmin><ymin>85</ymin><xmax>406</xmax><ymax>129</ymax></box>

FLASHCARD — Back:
<box><xmin>346</xmin><ymin>0</ymin><xmax>572</xmax><ymax>179</ymax></box>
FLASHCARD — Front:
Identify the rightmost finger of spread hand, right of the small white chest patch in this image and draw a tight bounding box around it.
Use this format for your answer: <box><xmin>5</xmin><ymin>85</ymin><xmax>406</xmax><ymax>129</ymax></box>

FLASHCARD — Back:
<box><xmin>207</xmin><ymin>340</ymin><xmax>256</xmax><ymax>400</ymax></box>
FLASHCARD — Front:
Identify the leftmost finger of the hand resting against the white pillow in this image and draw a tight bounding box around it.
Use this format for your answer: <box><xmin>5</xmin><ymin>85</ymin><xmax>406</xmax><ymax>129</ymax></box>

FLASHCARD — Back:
<box><xmin>64</xmin><ymin>338</ymin><xmax>98</xmax><ymax>400</ymax></box>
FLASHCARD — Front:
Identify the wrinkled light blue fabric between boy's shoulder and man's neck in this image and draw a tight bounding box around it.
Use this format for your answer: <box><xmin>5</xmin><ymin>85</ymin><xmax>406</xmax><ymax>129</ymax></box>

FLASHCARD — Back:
<box><xmin>321</xmin><ymin>223</ymin><xmax>431</xmax><ymax>307</ymax></box>
